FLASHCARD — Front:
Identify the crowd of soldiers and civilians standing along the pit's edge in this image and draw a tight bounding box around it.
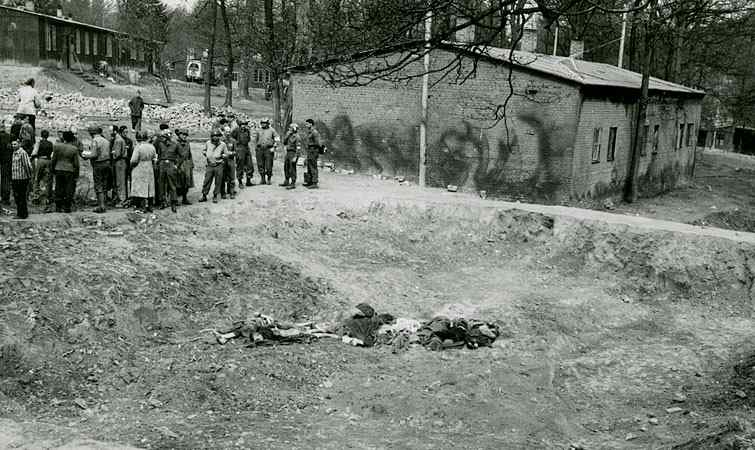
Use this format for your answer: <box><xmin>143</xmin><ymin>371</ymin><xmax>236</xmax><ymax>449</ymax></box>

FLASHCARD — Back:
<box><xmin>0</xmin><ymin>79</ymin><xmax>324</xmax><ymax>219</ymax></box>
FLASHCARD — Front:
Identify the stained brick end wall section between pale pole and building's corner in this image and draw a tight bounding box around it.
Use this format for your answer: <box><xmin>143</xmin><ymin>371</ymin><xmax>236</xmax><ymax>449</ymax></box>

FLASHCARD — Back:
<box><xmin>427</xmin><ymin>52</ymin><xmax>580</xmax><ymax>201</ymax></box>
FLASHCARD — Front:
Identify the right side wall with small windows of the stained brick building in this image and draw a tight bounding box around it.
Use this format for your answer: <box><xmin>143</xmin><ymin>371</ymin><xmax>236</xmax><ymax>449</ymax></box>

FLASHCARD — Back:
<box><xmin>572</xmin><ymin>97</ymin><xmax>700</xmax><ymax>198</ymax></box>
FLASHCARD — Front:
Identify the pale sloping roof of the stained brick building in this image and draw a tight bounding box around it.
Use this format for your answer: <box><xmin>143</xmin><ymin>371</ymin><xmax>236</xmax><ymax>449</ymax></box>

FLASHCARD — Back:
<box><xmin>444</xmin><ymin>43</ymin><xmax>705</xmax><ymax>95</ymax></box>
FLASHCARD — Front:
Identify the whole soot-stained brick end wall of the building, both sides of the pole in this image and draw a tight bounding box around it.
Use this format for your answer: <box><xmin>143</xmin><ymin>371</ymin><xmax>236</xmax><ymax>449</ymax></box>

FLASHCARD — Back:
<box><xmin>293</xmin><ymin>50</ymin><xmax>580</xmax><ymax>200</ymax></box>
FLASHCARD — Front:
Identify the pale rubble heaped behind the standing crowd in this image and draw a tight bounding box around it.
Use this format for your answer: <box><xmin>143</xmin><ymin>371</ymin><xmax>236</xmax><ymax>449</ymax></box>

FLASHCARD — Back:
<box><xmin>0</xmin><ymin>89</ymin><xmax>255</xmax><ymax>133</ymax></box>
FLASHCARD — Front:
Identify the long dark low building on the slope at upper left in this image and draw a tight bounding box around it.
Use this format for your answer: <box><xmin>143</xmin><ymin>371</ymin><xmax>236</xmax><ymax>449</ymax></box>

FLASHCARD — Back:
<box><xmin>0</xmin><ymin>2</ymin><xmax>161</xmax><ymax>73</ymax></box>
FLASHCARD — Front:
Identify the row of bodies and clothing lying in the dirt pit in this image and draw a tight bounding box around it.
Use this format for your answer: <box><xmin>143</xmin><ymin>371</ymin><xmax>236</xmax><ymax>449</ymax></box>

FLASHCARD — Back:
<box><xmin>214</xmin><ymin>303</ymin><xmax>501</xmax><ymax>353</ymax></box>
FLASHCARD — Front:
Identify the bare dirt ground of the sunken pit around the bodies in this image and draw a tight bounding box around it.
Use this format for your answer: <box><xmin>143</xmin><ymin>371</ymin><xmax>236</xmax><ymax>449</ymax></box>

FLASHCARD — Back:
<box><xmin>0</xmin><ymin>149</ymin><xmax>755</xmax><ymax>449</ymax></box>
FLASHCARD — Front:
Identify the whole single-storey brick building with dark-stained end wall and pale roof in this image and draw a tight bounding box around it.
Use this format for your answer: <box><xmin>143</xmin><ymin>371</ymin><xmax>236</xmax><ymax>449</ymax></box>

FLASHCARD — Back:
<box><xmin>292</xmin><ymin>44</ymin><xmax>704</xmax><ymax>201</ymax></box>
